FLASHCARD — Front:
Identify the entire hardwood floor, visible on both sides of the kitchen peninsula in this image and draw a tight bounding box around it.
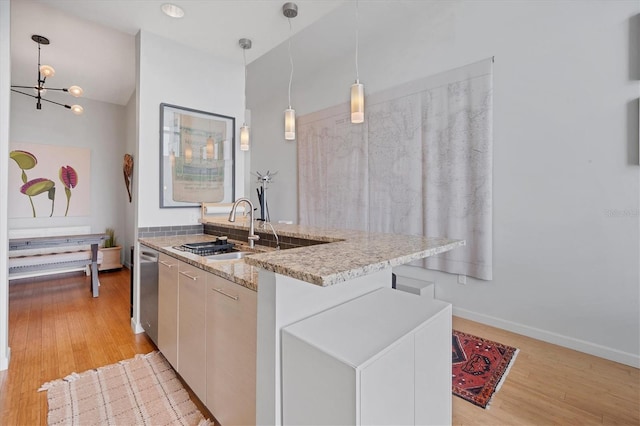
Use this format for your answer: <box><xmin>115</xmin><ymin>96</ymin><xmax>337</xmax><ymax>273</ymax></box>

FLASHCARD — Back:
<box><xmin>0</xmin><ymin>269</ymin><xmax>640</xmax><ymax>425</ymax></box>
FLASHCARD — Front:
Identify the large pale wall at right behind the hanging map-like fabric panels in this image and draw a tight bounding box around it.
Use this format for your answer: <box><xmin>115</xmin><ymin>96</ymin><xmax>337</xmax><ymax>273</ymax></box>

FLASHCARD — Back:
<box><xmin>248</xmin><ymin>0</ymin><xmax>640</xmax><ymax>366</ymax></box>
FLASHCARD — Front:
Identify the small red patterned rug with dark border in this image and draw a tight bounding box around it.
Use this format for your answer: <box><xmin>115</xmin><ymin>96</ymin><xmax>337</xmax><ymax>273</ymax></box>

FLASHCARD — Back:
<box><xmin>451</xmin><ymin>330</ymin><xmax>518</xmax><ymax>408</ymax></box>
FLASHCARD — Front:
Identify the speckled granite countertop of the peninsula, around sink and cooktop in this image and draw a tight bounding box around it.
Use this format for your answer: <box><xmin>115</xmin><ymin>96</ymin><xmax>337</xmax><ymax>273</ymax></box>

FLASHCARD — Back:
<box><xmin>140</xmin><ymin>221</ymin><xmax>465</xmax><ymax>290</ymax></box>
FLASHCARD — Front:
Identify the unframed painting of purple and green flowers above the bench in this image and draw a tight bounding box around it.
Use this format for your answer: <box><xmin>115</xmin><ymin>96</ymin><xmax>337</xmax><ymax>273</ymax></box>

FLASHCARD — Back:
<box><xmin>8</xmin><ymin>143</ymin><xmax>91</xmax><ymax>218</ymax></box>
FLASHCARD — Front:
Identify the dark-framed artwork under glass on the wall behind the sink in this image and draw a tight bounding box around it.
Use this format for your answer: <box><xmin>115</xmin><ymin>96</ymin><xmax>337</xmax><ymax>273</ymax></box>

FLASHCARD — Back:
<box><xmin>160</xmin><ymin>103</ymin><xmax>236</xmax><ymax>208</ymax></box>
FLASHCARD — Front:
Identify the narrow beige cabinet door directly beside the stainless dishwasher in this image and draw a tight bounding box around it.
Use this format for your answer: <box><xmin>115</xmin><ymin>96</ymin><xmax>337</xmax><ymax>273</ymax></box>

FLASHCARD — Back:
<box><xmin>158</xmin><ymin>253</ymin><xmax>180</xmax><ymax>369</ymax></box>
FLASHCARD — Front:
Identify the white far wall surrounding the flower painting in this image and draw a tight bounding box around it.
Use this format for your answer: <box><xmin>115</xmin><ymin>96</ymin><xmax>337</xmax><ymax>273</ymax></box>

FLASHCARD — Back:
<box><xmin>9</xmin><ymin>93</ymin><xmax>128</xmax><ymax>246</ymax></box>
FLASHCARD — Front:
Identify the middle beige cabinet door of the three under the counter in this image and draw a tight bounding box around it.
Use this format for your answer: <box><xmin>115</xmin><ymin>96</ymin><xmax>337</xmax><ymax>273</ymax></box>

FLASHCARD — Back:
<box><xmin>178</xmin><ymin>262</ymin><xmax>207</xmax><ymax>401</ymax></box>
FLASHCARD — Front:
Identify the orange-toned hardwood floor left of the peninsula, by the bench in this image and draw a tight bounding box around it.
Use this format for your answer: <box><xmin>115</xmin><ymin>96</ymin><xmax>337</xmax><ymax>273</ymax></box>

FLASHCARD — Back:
<box><xmin>0</xmin><ymin>269</ymin><xmax>156</xmax><ymax>425</ymax></box>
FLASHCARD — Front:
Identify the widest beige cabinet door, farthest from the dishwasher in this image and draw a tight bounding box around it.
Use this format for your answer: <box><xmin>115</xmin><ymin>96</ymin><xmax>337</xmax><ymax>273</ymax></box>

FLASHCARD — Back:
<box><xmin>206</xmin><ymin>274</ymin><xmax>257</xmax><ymax>426</ymax></box>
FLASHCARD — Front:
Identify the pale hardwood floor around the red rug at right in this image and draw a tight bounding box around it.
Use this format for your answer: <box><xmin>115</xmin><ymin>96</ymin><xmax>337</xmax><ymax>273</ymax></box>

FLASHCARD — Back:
<box><xmin>453</xmin><ymin>318</ymin><xmax>640</xmax><ymax>425</ymax></box>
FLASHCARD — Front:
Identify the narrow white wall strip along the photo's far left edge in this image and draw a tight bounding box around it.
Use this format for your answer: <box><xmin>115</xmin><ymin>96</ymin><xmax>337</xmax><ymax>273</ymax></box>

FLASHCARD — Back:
<box><xmin>0</xmin><ymin>0</ymin><xmax>11</xmax><ymax>371</ymax></box>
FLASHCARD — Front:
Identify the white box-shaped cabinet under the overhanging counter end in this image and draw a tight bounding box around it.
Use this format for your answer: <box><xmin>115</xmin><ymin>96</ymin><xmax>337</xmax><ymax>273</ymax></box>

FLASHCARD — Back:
<box><xmin>282</xmin><ymin>288</ymin><xmax>451</xmax><ymax>425</ymax></box>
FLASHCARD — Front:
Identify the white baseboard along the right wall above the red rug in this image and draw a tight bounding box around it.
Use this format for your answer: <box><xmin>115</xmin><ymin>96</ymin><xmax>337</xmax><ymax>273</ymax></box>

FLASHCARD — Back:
<box><xmin>453</xmin><ymin>307</ymin><xmax>640</xmax><ymax>368</ymax></box>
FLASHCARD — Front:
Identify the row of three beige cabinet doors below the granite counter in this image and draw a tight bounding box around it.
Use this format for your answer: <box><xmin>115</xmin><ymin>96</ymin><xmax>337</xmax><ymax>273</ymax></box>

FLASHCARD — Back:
<box><xmin>158</xmin><ymin>253</ymin><xmax>257</xmax><ymax>426</ymax></box>
